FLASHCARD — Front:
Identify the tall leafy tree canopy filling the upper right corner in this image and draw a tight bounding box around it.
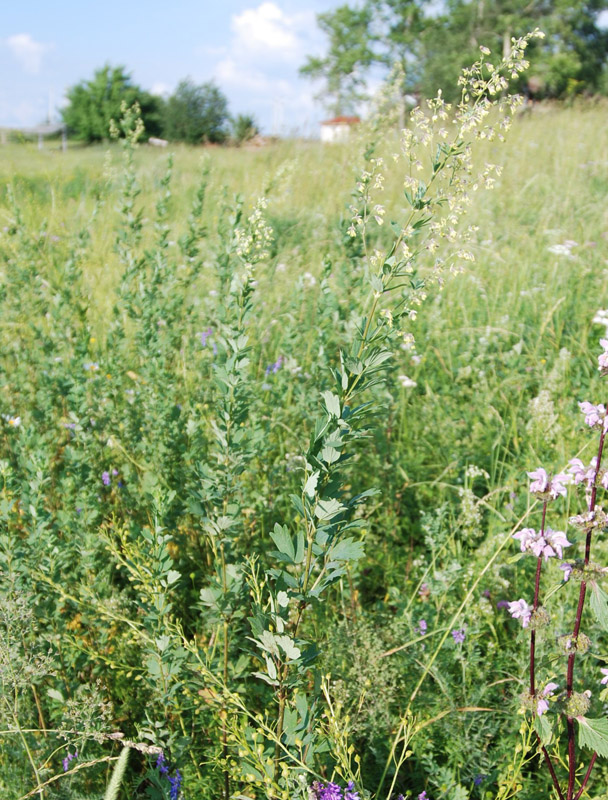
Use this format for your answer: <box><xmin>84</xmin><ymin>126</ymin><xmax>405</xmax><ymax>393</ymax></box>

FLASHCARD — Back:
<box><xmin>301</xmin><ymin>0</ymin><xmax>608</xmax><ymax>112</ymax></box>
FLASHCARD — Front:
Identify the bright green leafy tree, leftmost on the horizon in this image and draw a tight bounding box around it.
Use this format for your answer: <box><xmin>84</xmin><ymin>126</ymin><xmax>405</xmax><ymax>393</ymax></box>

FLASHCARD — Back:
<box><xmin>61</xmin><ymin>64</ymin><xmax>162</xmax><ymax>143</ymax></box>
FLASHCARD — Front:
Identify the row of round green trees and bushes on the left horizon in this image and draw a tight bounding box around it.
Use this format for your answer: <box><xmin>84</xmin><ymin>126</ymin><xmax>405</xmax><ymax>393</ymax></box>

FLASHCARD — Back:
<box><xmin>62</xmin><ymin>64</ymin><xmax>257</xmax><ymax>144</ymax></box>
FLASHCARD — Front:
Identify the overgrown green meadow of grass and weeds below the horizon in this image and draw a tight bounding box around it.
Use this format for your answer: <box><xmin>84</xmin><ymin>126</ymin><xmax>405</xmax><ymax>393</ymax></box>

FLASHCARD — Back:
<box><xmin>0</xmin><ymin>104</ymin><xmax>608</xmax><ymax>800</ymax></box>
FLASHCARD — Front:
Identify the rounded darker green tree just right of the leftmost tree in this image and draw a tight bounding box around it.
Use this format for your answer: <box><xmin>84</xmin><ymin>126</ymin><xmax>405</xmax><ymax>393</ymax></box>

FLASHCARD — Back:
<box><xmin>164</xmin><ymin>78</ymin><xmax>230</xmax><ymax>144</ymax></box>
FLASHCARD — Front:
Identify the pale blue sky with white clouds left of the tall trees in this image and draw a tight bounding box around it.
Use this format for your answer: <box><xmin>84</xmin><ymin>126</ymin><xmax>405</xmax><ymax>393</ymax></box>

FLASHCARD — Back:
<box><xmin>0</xmin><ymin>0</ymin><xmax>340</xmax><ymax>134</ymax></box>
